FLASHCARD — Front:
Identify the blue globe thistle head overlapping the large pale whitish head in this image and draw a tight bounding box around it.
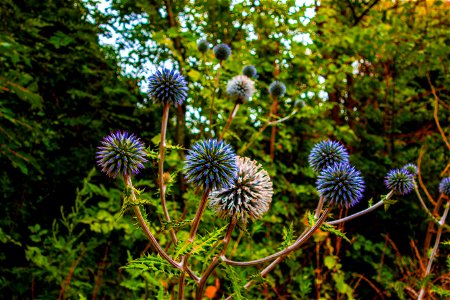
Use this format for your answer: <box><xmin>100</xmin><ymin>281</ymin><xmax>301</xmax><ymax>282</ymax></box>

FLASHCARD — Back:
<box><xmin>184</xmin><ymin>139</ymin><xmax>237</xmax><ymax>190</ymax></box>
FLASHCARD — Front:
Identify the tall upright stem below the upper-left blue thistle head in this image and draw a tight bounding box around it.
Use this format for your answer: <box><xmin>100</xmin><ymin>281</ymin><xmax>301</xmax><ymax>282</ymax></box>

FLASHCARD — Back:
<box><xmin>158</xmin><ymin>103</ymin><xmax>178</xmax><ymax>245</ymax></box>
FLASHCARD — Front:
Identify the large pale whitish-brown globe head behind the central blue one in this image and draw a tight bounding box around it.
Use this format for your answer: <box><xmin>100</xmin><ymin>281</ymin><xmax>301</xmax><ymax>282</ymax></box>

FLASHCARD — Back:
<box><xmin>209</xmin><ymin>156</ymin><xmax>273</xmax><ymax>223</ymax></box>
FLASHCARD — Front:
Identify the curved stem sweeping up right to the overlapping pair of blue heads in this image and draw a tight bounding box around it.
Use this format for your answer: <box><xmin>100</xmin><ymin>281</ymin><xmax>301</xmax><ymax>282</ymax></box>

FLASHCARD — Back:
<box><xmin>220</xmin><ymin>207</ymin><xmax>331</xmax><ymax>267</ymax></box>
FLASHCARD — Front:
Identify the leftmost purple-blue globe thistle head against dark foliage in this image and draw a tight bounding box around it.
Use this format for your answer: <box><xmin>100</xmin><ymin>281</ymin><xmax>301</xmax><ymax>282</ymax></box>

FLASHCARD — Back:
<box><xmin>97</xmin><ymin>131</ymin><xmax>147</xmax><ymax>178</ymax></box>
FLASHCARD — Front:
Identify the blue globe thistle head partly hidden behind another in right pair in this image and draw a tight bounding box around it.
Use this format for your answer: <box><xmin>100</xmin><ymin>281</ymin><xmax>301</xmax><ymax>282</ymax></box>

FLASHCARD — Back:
<box><xmin>308</xmin><ymin>140</ymin><xmax>349</xmax><ymax>172</ymax></box>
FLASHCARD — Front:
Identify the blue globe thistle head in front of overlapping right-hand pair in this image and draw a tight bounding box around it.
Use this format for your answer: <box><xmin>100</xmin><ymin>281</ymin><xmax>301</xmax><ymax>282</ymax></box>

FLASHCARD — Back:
<box><xmin>316</xmin><ymin>163</ymin><xmax>365</xmax><ymax>208</ymax></box>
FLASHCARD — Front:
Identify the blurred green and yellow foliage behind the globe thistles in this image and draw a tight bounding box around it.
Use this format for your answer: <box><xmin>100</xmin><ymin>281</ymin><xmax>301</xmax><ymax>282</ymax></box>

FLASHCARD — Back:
<box><xmin>0</xmin><ymin>0</ymin><xmax>450</xmax><ymax>299</ymax></box>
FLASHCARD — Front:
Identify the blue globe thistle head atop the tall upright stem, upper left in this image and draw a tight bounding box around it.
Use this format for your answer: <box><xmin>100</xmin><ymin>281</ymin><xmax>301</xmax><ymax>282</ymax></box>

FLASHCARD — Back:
<box><xmin>148</xmin><ymin>68</ymin><xmax>188</xmax><ymax>105</ymax></box>
